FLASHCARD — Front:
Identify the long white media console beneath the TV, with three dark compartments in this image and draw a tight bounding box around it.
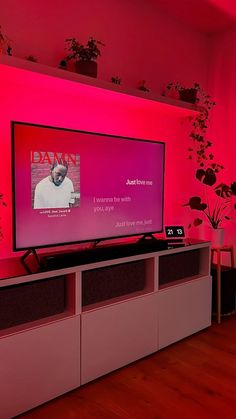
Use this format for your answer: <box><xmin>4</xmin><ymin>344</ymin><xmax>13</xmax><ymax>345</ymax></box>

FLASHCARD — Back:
<box><xmin>0</xmin><ymin>242</ymin><xmax>212</xmax><ymax>419</ymax></box>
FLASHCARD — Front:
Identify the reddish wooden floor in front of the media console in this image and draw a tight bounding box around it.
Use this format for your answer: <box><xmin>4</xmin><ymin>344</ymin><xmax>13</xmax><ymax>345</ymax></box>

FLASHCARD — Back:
<box><xmin>18</xmin><ymin>315</ymin><xmax>236</xmax><ymax>419</ymax></box>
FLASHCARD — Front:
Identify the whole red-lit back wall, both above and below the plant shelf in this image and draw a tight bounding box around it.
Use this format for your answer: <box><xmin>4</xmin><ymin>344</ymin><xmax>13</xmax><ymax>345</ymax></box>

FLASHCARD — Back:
<box><xmin>0</xmin><ymin>0</ymin><xmax>229</xmax><ymax>257</ymax></box>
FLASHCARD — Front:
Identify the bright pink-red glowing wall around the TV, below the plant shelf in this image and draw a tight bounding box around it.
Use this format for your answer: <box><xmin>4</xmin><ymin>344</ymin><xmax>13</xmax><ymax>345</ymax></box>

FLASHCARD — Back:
<box><xmin>0</xmin><ymin>57</ymin><xmax>199</xmax><ymax>257</ymax></box>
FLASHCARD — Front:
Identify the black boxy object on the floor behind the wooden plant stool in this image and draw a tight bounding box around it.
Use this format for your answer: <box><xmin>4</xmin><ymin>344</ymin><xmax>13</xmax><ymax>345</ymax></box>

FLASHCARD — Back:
<box><xmin>211</xmin><ymin>266</ymin><xmax>236</xmax><ymax>315</ymax></box>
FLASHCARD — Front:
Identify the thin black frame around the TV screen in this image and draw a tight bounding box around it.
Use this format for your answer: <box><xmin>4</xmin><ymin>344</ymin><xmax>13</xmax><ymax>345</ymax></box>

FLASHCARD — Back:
<box><xmin>11</xmin><ymin>120</ymin><xmax>165</xmax><ymax>252</ymax></box>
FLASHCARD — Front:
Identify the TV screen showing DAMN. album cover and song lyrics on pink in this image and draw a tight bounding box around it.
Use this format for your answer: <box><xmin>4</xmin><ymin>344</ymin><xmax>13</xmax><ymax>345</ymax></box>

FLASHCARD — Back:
<box><xmin>12</xmin><ymin>121</ymin><xmax>165</xmax><ymax>250</ymax></box>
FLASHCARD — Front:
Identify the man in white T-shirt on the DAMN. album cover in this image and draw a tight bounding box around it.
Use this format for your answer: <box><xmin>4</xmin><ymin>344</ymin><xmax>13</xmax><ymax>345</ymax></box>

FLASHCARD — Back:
<box><xmin>34</xmin><ymin>159</ymin><xmax>75</xmax><ymax>209</ymax></box>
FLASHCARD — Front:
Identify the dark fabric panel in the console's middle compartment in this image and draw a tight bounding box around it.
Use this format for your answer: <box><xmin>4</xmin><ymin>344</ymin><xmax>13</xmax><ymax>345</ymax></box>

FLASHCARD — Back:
<box><xmin>82</xmin><ymin>260</ymin><xmax>146</xmax><ymax>306</ymax></box>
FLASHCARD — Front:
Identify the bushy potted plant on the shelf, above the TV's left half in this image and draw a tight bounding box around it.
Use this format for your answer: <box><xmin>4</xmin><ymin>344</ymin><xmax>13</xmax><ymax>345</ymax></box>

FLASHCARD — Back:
<box><xmin>62</xmin><ymin>37</ymin><xmax>104</xmax><ymax>77</ymax></box>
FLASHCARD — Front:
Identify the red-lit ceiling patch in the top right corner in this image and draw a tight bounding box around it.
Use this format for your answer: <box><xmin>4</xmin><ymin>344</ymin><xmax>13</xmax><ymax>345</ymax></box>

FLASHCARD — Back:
<box><xmin>156</xmin><ymin>0</ymin><xmax>236</xmax><ymax>33</ymax></box>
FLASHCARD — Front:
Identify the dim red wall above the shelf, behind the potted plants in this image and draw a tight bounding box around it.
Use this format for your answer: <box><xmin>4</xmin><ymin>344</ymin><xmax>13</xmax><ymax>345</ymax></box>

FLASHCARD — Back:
<box><xmin>1</xmin><ymin>0</ymin><xmax>208</xmax><ymax>93</ymax></box>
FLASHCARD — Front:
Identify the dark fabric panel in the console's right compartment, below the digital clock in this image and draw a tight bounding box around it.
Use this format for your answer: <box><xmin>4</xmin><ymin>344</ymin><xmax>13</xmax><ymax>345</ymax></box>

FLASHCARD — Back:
<box><xmin>159</xmin><ymin>249</ymin><xmax>200</xmax><ymax>285</ymax></box>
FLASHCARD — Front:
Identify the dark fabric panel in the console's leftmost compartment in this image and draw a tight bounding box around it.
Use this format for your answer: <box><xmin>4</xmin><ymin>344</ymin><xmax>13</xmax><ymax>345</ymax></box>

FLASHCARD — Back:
<box><xmin>0</xmin><ymin>276</ymin><xmax>65</xmax><ymax>329</ymax></box>
